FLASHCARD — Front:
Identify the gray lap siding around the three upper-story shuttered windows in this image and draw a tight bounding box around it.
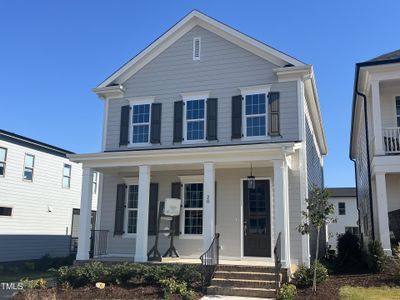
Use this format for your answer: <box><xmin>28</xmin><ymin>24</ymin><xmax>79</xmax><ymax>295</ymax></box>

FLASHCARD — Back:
<box><xmin>106</xmin><ymin>26</ymin><xmax>299</xmax><ymax>150</ymax></box>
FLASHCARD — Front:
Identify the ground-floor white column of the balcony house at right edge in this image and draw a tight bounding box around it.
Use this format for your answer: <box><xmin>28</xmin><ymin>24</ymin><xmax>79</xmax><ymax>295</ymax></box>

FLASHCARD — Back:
<box><xmin>375</xmin><ymin>173</ymin><xmax>392</xmax><ymax>255</ymax></box>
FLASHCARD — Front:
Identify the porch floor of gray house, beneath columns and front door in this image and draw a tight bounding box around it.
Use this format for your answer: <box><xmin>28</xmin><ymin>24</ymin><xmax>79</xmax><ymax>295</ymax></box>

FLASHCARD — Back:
<box><xmin>92</xmin><ymin>256</ymin><xmax>275</xmax><ymax>267</ymax></box>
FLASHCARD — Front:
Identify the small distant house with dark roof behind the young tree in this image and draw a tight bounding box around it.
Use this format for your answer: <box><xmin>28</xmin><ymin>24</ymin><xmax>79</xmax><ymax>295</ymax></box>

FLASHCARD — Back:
<box><xmin>328</xmin><ymin>188</ymin><xmax>360</xmax><ymax>251</ymax></box>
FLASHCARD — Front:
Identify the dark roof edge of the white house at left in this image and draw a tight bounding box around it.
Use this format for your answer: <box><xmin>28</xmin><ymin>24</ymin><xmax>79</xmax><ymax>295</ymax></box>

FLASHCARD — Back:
<box><xmin>0</xmin><ymin>129</ymin><xmax>75</xmax><ymax>157</ymax></box>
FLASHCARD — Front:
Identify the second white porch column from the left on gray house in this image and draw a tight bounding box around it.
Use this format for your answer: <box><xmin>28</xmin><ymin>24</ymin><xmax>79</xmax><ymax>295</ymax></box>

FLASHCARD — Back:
<box><xmin>135</xmin><ymin>166</ymin><xmax>150</xmax><ymax>262</ymax></box>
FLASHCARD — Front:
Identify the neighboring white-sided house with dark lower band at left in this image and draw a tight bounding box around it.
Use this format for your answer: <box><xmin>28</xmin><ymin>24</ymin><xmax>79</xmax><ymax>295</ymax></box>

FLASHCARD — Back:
<box><xmin>0</xmin><ymin>130</ymin><xmax>98</xmax><ymax>261</ymax></box>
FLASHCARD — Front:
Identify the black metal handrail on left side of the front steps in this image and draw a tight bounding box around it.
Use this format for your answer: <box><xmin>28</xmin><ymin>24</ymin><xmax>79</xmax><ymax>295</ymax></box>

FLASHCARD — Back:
<box><xmin>200</xmin><ymin>233</ymin><xmax>220</xmax><ymax>291</ymax></box>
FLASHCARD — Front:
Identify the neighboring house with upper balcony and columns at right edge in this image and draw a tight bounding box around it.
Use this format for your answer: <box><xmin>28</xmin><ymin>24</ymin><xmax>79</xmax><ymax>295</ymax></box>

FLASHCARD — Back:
<box><xmin>350</xmin><ymin>50</ymin><xmax>400</xmax><ymax>255</ymax></box>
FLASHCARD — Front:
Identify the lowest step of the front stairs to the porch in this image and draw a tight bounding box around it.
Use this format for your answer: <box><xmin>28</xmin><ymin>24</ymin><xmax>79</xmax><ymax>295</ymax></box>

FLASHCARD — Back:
<box><xmin>207</xmin><ymin>285</ymin><xmax>275</xmax><ymax>298</ymax></box>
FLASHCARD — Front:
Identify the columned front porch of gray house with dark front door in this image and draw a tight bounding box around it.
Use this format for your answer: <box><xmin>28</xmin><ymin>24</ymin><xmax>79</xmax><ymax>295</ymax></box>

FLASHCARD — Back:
<box><xmin>72</xmin><ymin>144</ymin><xmax>303</xmax><ymax>268</ymax></box>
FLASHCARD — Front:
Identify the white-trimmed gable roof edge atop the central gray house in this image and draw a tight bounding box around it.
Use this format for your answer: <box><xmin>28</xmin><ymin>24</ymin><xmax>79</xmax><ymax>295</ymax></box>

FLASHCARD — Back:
<box><xmin>94</xmin><ymin>10</ymin><xmax>305</xmax><ymax>91</ymax></box>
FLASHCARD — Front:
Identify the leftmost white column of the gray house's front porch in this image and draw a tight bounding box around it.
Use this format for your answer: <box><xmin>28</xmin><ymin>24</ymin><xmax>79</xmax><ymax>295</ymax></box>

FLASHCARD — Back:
<box><xmin>76</xmin><ymin>167</ymin><xmax>93</xmax><ymax>260</ymax></box>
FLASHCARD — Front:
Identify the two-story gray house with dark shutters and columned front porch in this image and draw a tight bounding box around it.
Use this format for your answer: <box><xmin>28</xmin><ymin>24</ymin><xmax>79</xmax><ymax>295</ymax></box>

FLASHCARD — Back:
<box><xmin>70</xmin><ymin>11</ymin><xmax>327</xmax><ymax>284</ymax></box>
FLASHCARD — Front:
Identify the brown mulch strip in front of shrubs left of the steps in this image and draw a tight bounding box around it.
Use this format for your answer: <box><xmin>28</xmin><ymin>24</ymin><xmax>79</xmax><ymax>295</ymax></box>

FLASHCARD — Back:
<box><xmin>12</xmin><ymin>286</ymin><xmax>202</xmax><ymax>300</ymax></box>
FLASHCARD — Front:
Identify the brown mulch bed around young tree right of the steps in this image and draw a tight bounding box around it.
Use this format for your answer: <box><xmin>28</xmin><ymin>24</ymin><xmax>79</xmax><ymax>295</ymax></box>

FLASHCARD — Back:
<box><xmin>296</xmin><ymin>273</ymin><xmax>400</xmax><ymax>300</ymax></box>
